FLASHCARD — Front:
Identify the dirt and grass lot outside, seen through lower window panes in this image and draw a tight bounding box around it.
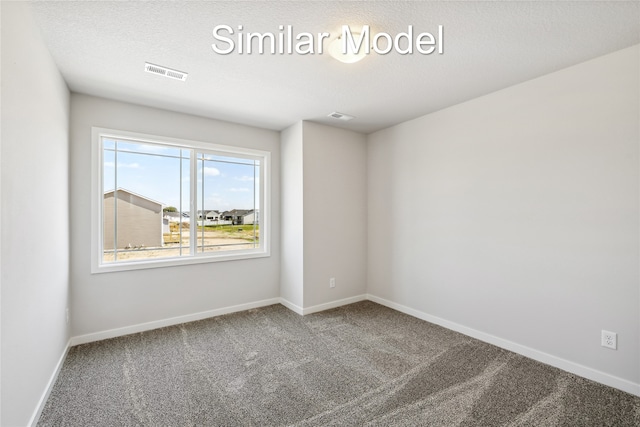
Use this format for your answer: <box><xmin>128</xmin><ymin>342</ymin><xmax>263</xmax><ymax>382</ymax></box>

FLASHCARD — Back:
<box><xmin>103</xmin><ymin>226</ymin><xmax>257</xmax><ymax>262</ymax></box>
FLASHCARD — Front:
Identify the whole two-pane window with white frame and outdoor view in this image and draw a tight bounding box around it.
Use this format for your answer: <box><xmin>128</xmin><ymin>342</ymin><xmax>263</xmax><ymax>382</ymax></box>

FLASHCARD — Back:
<box><xmin>92</xmin><ymin>128</ymin><xmax>270</xmax><ymax>273</ymax></box>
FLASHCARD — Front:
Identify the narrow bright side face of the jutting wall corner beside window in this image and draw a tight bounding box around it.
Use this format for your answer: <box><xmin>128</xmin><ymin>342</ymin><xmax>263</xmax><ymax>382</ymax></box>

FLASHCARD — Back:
<box><xmin>280</xmin><ymin>122</ymin><xmax>304</xmax><ymax>312</ymax></box>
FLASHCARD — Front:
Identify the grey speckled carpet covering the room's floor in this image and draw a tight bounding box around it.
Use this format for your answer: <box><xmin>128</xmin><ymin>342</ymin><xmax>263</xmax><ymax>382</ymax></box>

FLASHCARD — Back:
<box><xmin>38</xmin><ymin>302</ymin><xmax>640</xmax><ymax>427</ymax></box>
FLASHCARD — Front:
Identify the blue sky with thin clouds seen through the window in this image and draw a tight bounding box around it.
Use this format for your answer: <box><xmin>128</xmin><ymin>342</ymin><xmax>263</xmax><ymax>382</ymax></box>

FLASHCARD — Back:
<box><xmin>103</xmin><ymin>140</ymin><xmax>259</xmax><ymax>211</ymax></box>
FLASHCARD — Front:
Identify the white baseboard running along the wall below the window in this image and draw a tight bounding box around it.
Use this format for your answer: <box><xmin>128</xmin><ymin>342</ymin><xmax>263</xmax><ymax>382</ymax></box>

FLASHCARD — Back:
<box><xmin>71</xmin><ymin>298</ymin><xmax>281</xmax><ymax>346</ymax></box>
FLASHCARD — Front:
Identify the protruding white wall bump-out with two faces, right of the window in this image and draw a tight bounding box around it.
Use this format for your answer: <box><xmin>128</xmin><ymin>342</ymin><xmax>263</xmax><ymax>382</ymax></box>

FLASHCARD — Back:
<box><xmin>280</xmin><ymin>121</ymin><xmax>367</xmax><ymax>314</ymax></box>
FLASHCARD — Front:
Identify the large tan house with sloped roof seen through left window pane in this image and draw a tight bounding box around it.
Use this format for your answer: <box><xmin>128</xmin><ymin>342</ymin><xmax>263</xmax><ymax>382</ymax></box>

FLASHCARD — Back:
<box><xmin>103</xmin><ymin>188</ymin><xmax>163</xmax><ymax>249</ymax></box>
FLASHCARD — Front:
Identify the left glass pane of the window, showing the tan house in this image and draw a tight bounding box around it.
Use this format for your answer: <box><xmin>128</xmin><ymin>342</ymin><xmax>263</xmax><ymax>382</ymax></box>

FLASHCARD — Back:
<box><xmin>103</xmin><ymin>140</ymin><xmax>190</xmax><ymax>262</ymax></box>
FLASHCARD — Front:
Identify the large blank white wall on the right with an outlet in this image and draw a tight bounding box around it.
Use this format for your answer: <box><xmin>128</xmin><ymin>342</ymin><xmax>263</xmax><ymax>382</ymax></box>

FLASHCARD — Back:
<box><xmin>368</xmin><ymin>46</ymin><xmax>640</xmax><ymax>393</ymax></box>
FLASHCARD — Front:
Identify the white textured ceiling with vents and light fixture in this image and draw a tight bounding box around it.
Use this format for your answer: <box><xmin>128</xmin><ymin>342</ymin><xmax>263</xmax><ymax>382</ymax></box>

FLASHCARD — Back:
<box><xmin>27</xmin><ymin>1</ymin><xmax>640</xmax><ymax>133</ymax></box>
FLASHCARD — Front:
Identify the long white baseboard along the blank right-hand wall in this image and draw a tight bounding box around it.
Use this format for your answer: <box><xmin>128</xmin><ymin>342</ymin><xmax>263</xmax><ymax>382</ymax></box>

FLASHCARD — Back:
<box><xmin>367</xmin><ymin>294</ymin><xmax>640</xmax><ymax>396</ymax></box>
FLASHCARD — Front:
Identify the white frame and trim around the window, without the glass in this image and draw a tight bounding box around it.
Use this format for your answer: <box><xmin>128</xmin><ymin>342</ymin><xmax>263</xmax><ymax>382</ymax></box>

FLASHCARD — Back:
<box><xmin>91</xmin><ymin>127</ymin><xmax>271</xmax><ymax>274</ymax></box>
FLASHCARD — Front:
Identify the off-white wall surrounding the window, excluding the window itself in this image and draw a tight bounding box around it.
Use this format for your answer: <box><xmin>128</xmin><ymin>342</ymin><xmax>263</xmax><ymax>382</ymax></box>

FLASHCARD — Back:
<box><xmin>71</xmin><ymin>94</ymin><xmax>280</xmax><ymax>336</ymax></box>
